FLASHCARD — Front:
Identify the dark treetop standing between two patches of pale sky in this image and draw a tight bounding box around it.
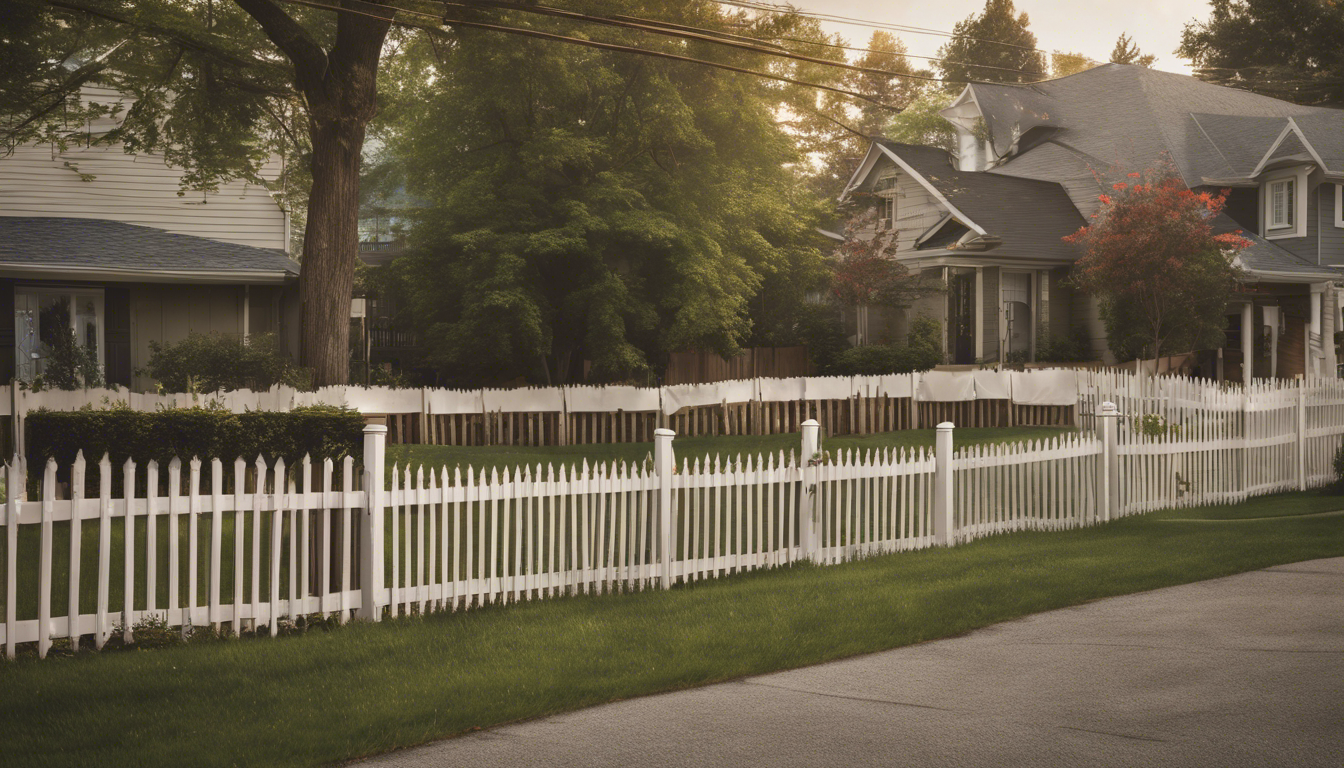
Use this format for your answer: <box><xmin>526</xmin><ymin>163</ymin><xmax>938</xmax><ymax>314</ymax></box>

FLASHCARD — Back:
<box><xmin>938</xmin><ymin>0</ymin><xmax>1047</xmax><ymax>91</ymax></box>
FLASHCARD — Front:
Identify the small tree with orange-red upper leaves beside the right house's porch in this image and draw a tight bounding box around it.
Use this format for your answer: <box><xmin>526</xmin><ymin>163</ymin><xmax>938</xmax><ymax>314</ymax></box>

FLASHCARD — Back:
<box><xmin>1064</xmin><ymin>163</ymin><xmax>1250</xmax><ymax>360</ymax></box>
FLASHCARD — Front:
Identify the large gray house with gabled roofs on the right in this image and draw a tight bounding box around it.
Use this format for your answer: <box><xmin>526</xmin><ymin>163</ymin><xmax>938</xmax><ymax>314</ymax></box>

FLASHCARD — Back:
<box><xmin>841</xmin><ymin>65</ymin><xmax>1344</xmax><ymax>381</ymax></box>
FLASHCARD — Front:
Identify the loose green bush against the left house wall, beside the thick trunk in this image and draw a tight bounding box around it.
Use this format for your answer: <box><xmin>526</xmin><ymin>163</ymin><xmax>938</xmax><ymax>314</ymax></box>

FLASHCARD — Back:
<box><xmin>136</xmin><ymin>334</ymin><xmax>312</xmax><ymax>393</ymax></box>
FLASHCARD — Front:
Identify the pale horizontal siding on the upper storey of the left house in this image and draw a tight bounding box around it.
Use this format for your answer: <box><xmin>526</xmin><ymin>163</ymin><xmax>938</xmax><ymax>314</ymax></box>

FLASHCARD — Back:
<box><xmin>0</xmin><ymin>145</ymin><xmax>288</xmax><ymax>249</ymax></box>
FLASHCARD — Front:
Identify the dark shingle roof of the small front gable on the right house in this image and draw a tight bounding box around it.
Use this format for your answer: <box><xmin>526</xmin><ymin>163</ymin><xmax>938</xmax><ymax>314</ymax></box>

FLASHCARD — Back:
<box><xmin>882</xmin><ymin>140</ymin><xmax>1083</xmax><ymax>260</ymax></box>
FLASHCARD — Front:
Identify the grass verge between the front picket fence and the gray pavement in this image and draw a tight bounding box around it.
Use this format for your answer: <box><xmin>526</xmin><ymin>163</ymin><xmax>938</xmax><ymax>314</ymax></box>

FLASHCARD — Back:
<box><xmin>0</xmin><ymin>492</ymin><xmax>1344</xmax><ymax>767</ymax></box>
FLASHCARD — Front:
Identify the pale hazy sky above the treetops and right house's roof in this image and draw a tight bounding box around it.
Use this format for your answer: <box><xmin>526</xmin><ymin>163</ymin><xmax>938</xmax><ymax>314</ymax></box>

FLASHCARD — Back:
<box><xmin>793</xmin><ymin>0</ymin><xmax>1208</xmax><ymax>74</ymax></box>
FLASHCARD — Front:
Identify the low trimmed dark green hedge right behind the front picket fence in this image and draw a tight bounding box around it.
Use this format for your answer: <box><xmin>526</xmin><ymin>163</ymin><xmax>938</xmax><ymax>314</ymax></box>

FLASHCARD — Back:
<box><xmin>26</xmin><ymin>406</ymin><xmax>364</xmax><ymax>482</ymax></box>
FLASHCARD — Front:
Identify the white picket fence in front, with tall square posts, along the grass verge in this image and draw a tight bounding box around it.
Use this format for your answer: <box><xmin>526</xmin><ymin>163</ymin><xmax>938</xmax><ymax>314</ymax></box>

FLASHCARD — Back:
<box><xmin>0</xmin><ymin>381</ymin><xmax>1344</xmax><ymax>656</ymax></box>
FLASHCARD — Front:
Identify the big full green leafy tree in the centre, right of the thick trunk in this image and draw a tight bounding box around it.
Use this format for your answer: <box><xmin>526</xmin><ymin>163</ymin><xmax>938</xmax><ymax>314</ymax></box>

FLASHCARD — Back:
<box><xmin>380</xmin><ymin>0</ymin><xmax>825</xmax><ymax>383</ymax></box>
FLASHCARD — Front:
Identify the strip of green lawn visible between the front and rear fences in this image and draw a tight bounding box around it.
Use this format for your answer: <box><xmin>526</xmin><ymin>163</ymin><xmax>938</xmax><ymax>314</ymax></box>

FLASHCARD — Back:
<box><xmin>387</xmin><ymin>426</ymin><xmax>1074</xmax><ymax>478</ymax></box>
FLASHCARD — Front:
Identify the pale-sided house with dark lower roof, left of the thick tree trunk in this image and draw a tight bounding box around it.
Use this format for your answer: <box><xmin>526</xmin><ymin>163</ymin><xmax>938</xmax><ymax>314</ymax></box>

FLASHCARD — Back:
<box><xmin>0</xmin><ymin>87</ymin><xmax>298</xmax><ymax>390</ymax></box>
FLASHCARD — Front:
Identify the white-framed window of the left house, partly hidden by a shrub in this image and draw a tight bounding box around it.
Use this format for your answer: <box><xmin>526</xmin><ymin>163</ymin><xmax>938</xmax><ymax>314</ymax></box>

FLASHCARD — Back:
<box><xmin>13</xmin><ymin>286</ymin><xmax>106</xmax><ymax>381</ymax></box>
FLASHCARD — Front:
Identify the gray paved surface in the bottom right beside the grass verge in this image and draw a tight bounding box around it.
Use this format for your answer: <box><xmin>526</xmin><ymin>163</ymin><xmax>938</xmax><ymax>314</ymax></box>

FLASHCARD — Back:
<box><xmin>366</xmin><ymin>558</ymin><xmax>1344</xmax><ymax>768</ymax></box>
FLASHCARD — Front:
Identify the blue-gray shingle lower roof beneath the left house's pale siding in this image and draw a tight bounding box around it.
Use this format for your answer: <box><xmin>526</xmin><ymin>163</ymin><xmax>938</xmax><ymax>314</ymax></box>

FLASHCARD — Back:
<box><xmin>0</xmin><ymin>217</ymin><xmax>298</xmax><ymax>276</ymax></box>
